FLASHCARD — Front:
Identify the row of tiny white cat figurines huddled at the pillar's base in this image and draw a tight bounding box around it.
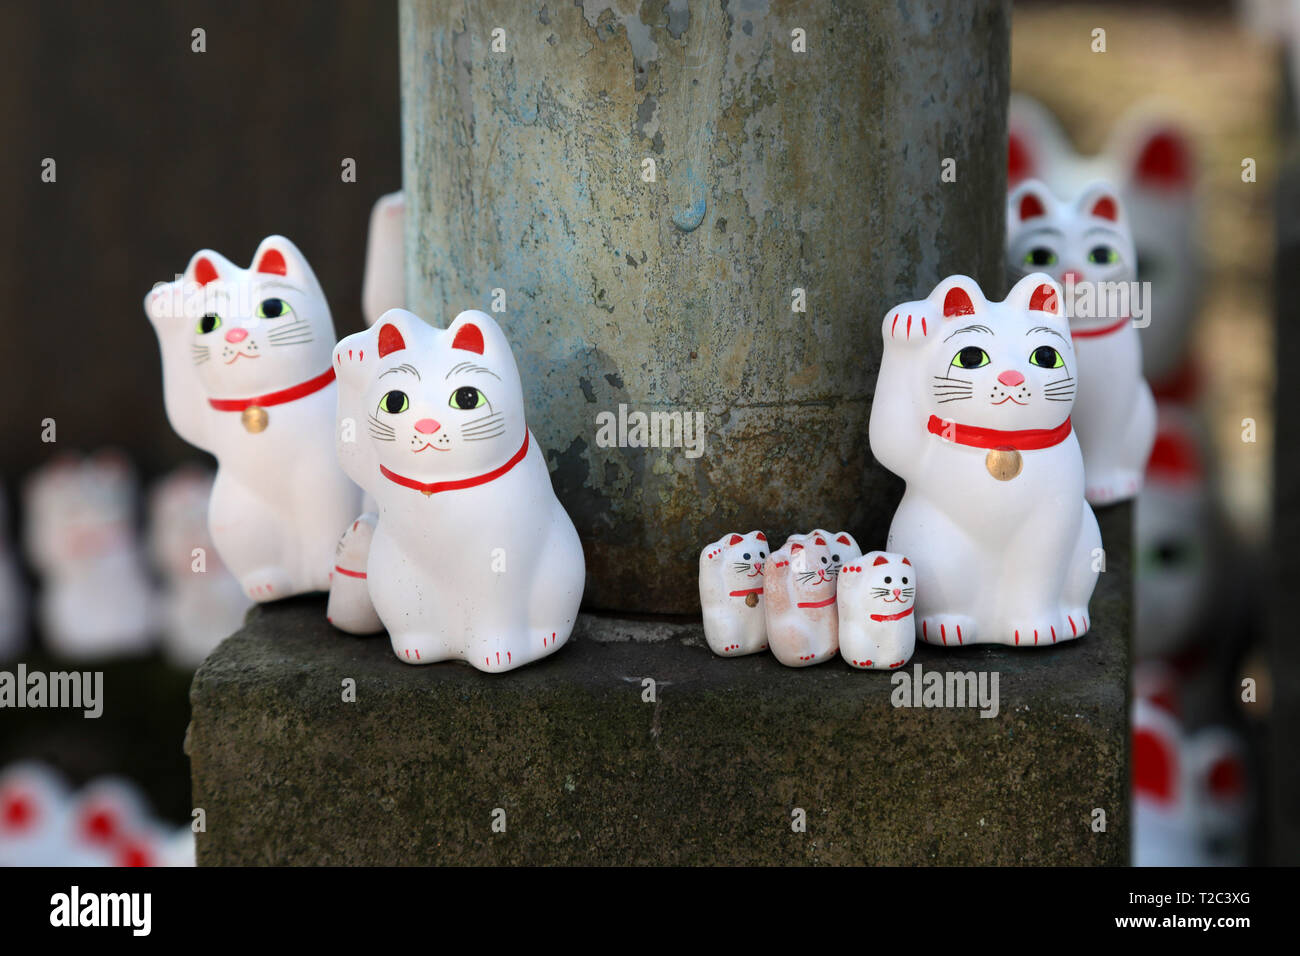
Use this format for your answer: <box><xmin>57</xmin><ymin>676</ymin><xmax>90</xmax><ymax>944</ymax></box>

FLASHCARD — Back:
<box><xmin>699</xmin><ymin>528</ymin><xmax>917</xmax><ymax>670</ymax></box>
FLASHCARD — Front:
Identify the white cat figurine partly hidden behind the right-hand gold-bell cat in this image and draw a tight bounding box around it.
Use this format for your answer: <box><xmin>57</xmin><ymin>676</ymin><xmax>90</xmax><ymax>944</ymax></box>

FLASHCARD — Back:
<box><xmin>1006</xmin><ymin>179</ymin><xmax>1156</xmax><ymax>505</ymax></box>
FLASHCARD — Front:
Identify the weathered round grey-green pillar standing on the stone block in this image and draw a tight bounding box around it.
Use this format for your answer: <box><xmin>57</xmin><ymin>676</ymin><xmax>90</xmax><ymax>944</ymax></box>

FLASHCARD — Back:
<box><xmin>400</xmin><ymin>0</ymin><xmax>1009</xmax><ymax>613</ymax></box>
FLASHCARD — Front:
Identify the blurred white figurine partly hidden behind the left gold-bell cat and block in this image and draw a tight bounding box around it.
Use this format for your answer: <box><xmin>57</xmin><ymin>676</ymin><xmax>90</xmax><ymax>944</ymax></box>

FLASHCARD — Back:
<box><xmin>148</xmin><ymin>466</ymin><xmax>252</xmax><ymax>669</ymax></box>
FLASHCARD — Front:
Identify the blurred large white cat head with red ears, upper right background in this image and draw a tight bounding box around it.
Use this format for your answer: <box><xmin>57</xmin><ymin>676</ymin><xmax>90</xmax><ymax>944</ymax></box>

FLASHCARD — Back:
<box><xmin>1008</xmin><ymin>94</ymin><xmax>1203</xmax><ymax>388</ymax></box>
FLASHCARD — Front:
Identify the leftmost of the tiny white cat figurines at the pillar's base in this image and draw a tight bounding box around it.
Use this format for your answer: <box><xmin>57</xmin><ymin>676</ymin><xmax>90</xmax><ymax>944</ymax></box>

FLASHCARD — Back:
<box><xmin>699</xmin><ymin>531</ymin><xmax>767</xmax><ymax>657</ymax></box>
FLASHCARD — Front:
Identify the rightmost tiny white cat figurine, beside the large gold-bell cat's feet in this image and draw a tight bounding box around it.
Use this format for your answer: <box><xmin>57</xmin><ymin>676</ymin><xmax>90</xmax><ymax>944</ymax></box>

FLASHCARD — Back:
<box><xmin>835</xmin><ymin>551</ymin><xmax>917</xmax><ymax>671</ymax></box>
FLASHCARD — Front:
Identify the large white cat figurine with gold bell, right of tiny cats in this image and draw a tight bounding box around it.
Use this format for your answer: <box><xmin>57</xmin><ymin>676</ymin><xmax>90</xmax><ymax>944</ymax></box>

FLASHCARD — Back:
<box><xmin>873</xmin><ymin>273</ymin><xmax>1101</xmax><ymax>648</ymax></box>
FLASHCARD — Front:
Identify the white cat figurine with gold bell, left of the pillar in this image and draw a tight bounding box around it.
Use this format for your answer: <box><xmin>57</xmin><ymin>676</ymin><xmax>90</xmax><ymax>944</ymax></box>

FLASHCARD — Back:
<box><xmin>144</xmin><ymin>235</ymin><xmax>361</xmax><ymax>601</ymax></box>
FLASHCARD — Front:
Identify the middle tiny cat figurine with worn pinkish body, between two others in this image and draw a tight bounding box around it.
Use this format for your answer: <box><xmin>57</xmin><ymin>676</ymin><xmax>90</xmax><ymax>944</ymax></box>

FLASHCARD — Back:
<box><xmin>763</xmin><ymin>531</ymin><xmax>862</xmax><ymax>667</ymax></box>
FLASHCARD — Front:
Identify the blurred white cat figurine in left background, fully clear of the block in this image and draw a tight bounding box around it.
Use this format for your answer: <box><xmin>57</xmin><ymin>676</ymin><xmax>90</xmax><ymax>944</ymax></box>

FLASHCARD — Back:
<box><xmin>23</xmin><ymin>451</ymin><xmax>156</xmax><ymax>658</ymax></box>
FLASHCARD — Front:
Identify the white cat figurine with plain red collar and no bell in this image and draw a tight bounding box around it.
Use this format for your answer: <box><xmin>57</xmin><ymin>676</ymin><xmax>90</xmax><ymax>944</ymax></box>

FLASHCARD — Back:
<box><xmin>334</xmin><ymin>310</ymin><xmax>586</xmax><ymax>671</ymax></box>
